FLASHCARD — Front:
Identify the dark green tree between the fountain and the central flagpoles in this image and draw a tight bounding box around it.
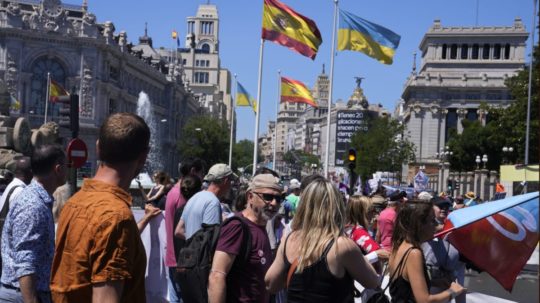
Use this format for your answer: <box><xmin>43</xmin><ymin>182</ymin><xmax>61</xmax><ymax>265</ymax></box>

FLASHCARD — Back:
<box><xmin>177</xmin><ymin>115</ymin><xmax>230</xmax><ymax>166</ymax></box>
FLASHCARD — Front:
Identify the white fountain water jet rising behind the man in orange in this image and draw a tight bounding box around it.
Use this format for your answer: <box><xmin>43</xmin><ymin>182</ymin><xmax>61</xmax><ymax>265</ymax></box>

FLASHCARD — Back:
<box><xmin>137</xmin><ymin>91</ymin><xmax>163</xmax><ymax>174</ymax></box>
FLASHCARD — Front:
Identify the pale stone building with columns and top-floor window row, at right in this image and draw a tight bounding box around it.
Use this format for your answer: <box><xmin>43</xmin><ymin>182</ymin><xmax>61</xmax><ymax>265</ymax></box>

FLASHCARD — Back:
<box><xmin>396</xmin><ymin>18</ymin><xmax>528</xmax><ymax>170</ymax></box>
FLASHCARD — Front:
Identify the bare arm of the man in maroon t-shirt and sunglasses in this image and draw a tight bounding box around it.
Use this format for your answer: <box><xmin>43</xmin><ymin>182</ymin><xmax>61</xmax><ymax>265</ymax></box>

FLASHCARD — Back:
<box><xmin>208</xmin><ymin>250</ymin><xmax>236</xmax><ymax>303</ymax></box>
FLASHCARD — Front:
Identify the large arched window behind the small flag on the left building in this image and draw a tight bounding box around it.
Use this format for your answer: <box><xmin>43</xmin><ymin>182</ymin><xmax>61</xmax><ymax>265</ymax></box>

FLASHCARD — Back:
<box><xmin>26</xmin><ymin>57</ymin><xmax>69</xmax><ymax>116</ymax></box>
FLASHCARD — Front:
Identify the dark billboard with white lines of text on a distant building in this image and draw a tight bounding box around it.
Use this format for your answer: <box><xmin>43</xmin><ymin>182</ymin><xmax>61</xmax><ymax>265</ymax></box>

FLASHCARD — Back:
<box><xmin>335</xmin><ymin>110</ymin><xmax>369</xmax><ymax>166</ymax></box>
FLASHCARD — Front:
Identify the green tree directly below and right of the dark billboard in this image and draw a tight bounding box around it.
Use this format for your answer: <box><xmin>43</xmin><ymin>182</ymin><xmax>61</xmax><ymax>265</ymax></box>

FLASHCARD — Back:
<box><xmin>345</xmin><ymin>117</ymin><xmax>414</xmax><ymax>180</ymax></box>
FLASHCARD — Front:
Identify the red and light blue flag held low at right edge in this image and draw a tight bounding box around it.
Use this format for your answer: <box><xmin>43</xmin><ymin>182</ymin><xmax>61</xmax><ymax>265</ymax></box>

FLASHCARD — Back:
<box><xmin>442</xmin><ymin>192</ymin><xmax>538</xmax><ymax>291</ymax></box>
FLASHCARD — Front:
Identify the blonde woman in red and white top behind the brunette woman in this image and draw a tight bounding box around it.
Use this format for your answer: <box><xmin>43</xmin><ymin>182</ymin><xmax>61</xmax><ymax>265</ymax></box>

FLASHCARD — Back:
<box><xmin>345</xmin><ymin>195</ymin><xmax>390</xmax><ymax>273</ymax></box>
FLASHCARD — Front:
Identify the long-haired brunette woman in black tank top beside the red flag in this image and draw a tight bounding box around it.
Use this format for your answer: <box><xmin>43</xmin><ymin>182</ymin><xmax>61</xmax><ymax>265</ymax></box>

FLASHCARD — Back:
<box><xmin>388</xmin><ymin>200</ymin><xmax>465</xmax><ymax>303</ymax></box>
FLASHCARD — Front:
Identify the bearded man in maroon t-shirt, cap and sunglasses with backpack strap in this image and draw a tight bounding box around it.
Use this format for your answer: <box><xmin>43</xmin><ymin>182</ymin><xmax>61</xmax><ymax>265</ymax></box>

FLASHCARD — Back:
<box><xmin>208</xmin><ymin>174</ymin><xmax>281</xmax><ymax>303</ymax></box>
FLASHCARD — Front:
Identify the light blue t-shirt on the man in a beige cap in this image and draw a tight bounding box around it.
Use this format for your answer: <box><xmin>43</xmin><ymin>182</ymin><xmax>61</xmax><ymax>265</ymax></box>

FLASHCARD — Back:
<box><xmin>181</xmin><ymin>190</ymin><xmax>221</xmax><ymax>240</ymax></box>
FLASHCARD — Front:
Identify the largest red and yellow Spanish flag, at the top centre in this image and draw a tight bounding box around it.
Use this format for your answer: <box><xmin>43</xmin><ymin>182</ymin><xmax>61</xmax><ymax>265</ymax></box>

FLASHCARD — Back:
<box><xmin>262</xmin><ymin>0</ymin><xmax>322</xmax><ymax>60</ymax></box>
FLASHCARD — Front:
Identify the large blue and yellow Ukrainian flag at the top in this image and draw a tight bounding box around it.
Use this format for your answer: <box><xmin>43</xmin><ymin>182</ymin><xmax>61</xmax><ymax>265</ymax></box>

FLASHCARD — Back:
<box><xmin>338</xmin><ymin>10</ymin><xmax>401</xmax><ymax>64</ymax></box>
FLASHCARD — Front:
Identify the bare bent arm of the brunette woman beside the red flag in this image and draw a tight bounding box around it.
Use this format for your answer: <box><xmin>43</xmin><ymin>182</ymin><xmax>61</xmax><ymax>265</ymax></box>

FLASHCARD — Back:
<box><xmin>405</xmin><ymin>249</ymin><xmax>466</xmax><ymax>303</ymax></box>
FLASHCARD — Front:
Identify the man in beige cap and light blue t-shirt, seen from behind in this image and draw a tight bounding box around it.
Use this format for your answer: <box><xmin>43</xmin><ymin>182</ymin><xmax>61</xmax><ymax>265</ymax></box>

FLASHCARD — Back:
<box><xmin>174</xmin><ymin>163</ymin><xmax>238</xmax><ymax>240</ymax></box>
